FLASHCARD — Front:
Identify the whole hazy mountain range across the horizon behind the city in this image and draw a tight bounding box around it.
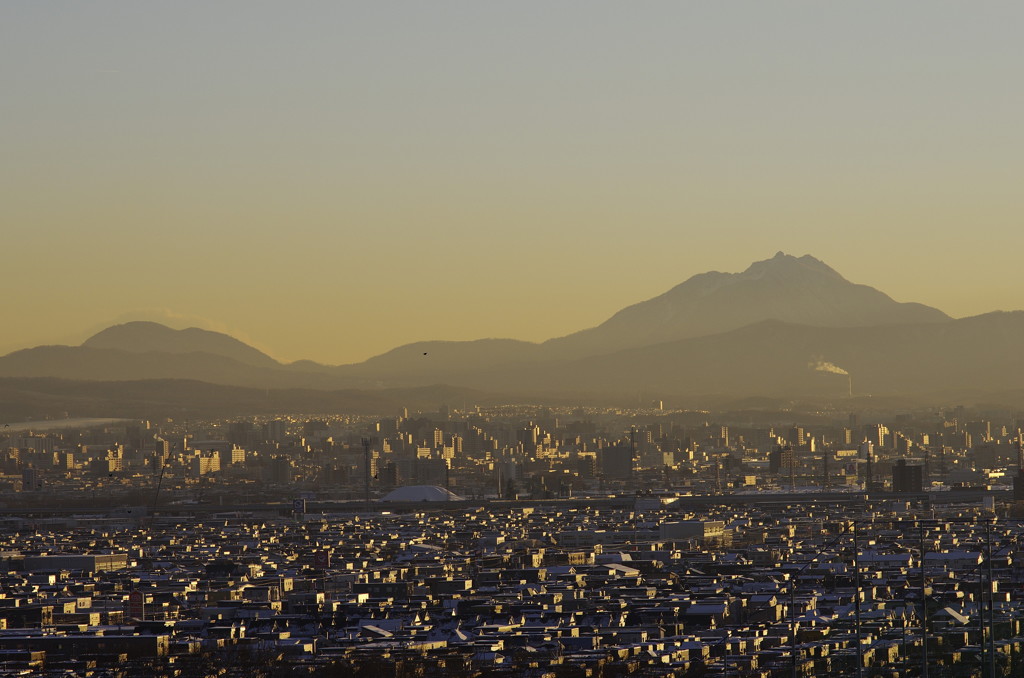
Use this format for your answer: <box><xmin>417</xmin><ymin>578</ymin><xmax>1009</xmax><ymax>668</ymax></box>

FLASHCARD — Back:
<box><xmin>0</xmin><ymin>252</ymin><xmax>1024</xmax><ymax>413</ymax></box>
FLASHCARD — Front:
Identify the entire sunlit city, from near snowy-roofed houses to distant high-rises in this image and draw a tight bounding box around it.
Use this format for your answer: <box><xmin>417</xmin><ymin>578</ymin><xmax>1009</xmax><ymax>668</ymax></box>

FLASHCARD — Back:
<box><xmin>0</xmin><ymin>407</ymin><xmax>1024</xmax><ymax>678</ymax></box>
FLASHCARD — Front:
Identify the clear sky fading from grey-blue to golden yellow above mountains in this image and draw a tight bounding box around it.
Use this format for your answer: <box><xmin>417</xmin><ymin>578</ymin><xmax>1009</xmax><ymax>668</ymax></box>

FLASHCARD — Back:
<box><xmin>0</xmin><ymin>0</ymin><xmax>1024</xmax><ymax>364</ymax></box>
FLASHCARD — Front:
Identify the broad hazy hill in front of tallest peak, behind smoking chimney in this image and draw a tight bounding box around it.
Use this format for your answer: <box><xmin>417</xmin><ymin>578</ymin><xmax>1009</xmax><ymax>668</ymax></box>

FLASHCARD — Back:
<box><xmin>475</xmin><ymin>311</ymin><xmax>1024</xmax><ymax>399</ymax></box>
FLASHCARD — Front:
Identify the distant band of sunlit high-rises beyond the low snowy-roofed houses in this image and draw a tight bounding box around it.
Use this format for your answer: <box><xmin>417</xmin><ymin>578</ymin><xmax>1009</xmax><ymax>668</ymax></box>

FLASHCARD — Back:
<box><xmin>0</xmin><ymin>407</ymin><xmax>1022</xmax><ymax>504</ymax></box>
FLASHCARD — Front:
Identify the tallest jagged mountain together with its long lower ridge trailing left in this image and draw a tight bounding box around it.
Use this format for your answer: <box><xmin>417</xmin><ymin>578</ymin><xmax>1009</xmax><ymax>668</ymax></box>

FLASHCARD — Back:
<box><xmin>339</xmin><ymin>252</ymin><xmax>951</xmax><ymax>379</ymax></box>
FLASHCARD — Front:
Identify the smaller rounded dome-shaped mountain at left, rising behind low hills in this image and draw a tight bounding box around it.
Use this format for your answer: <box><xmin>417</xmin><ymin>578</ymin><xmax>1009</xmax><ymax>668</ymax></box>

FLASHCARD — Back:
<box><xmin>82</xmin><ymin>321</ymin><xmax>281</xmax><ymax>368</ymax></box>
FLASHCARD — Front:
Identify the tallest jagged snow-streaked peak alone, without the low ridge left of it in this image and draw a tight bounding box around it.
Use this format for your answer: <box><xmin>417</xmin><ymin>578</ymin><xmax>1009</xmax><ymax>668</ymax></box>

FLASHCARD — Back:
<box><xmin>544</xmin><ymin>252</ymin><xmax>951</xmax><ymax>356</ymax></box>
